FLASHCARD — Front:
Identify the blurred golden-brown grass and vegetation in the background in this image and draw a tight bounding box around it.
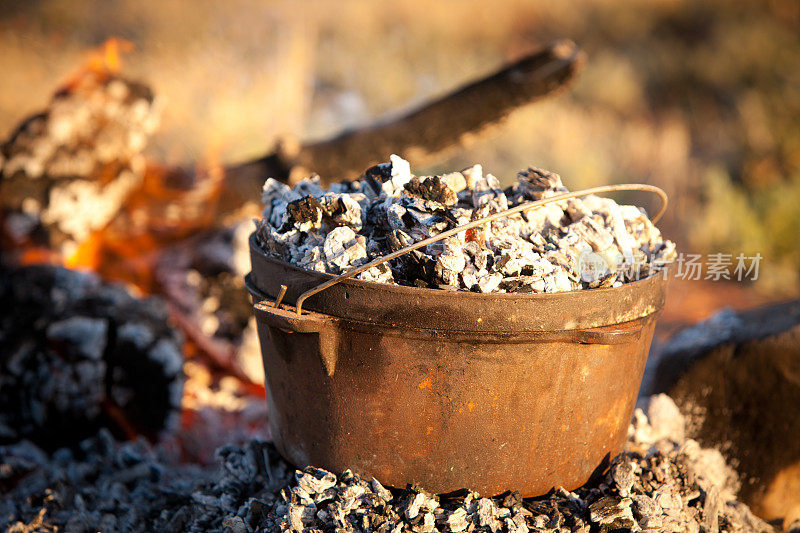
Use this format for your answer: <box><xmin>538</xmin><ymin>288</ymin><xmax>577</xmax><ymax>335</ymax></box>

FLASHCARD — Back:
<box><xmin>0</xmin><ymin>0</ymin><xmax>800</xmax><ymax>294</ymax></box>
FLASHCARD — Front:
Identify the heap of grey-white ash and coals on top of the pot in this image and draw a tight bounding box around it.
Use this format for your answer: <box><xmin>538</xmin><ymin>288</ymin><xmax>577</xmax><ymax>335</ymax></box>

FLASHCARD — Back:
<box><xmin>256</xmin><ymin>155</ymin><xmax>675</xmax><ymax>293</ymax></box>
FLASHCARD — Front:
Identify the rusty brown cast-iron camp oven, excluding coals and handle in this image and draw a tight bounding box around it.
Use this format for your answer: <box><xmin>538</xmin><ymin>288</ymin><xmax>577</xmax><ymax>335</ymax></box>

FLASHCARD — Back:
<box><xmin>247</xmin><ymin>235</ymin><xmax>666</xmax><ymax>496</ymax></box>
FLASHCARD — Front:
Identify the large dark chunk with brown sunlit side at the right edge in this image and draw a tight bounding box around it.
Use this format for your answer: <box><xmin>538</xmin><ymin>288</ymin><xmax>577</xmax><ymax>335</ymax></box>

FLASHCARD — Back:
<box><xmin>645</xmin><ymin>300</ymin><xmax>800</xmax><ymax>519</ymax></box>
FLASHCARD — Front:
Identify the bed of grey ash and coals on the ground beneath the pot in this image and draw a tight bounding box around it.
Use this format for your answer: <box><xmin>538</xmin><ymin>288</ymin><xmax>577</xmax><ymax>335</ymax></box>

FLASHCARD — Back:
<box><xmin>0</xmin><ymin>396</ymin><xmax>775</xmax><ymax>533</ymax></box>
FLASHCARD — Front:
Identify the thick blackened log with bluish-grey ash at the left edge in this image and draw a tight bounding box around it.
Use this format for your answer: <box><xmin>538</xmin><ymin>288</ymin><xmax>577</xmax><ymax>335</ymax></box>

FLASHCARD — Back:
<box><xmin>0</xmin><ymin>266</ymin><xmax>183</xmax><ymax>449</ymax></box>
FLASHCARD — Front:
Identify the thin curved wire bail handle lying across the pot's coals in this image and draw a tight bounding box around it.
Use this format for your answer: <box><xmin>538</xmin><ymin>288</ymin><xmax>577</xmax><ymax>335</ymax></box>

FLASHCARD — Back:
<box><xmin>273</xmin><ymin>183</ymin><xmax>669</xmax><ymax>316</ymax></box>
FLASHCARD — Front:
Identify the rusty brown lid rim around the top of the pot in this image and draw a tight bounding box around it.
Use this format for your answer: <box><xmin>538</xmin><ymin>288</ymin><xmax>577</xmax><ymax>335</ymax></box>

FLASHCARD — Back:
<box><xmin>249</xmin><ymin>231</ymin><xmax>668</xmax><ymax>331</ymax></box>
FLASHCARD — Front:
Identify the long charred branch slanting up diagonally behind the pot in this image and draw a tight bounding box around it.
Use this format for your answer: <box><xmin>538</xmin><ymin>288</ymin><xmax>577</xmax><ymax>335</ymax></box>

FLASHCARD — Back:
<box><xmin>220</xmin><ymin>40</ymin><xmax>585</xmax><ymax>218</ymax></box>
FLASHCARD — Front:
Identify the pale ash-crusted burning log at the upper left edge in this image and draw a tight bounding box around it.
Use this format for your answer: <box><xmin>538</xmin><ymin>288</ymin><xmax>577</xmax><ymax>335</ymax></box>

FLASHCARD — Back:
<box><xmin>0</xmin><ymin>70</ymin><xmax>159</xmax><ymax>257</ymax></box>
